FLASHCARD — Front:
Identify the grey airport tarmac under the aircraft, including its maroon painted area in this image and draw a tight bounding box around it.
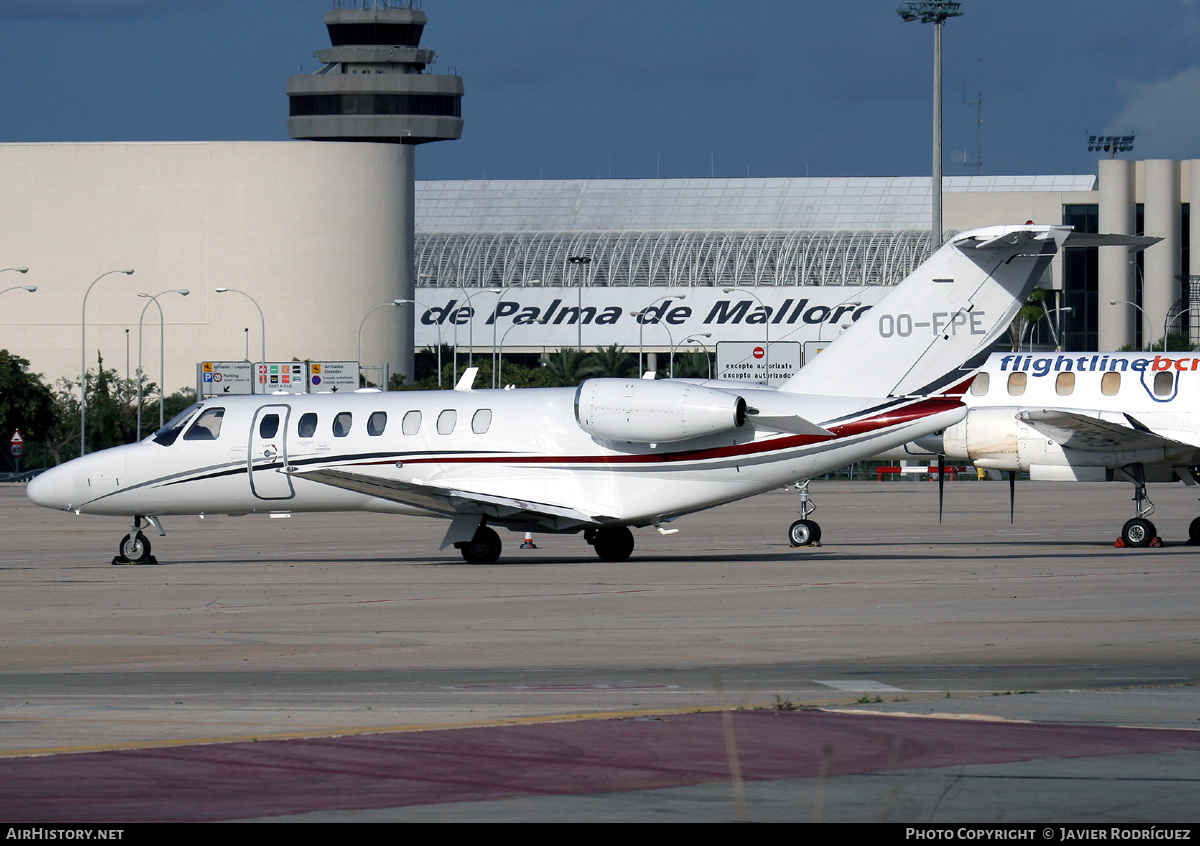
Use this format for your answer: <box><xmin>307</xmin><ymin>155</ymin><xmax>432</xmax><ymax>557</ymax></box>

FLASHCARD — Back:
<box><xmin>0</xmin><ymin>480</ymin><xmax>1200</xmax><ymax>823</ymax></box>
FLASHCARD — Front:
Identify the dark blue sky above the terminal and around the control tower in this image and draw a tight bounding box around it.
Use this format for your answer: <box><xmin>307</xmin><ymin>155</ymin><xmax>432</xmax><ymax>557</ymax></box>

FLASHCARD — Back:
<box><xmin>0</xmin><ymin>0</ymin><xmax>1200</xmax><ymax>179</ymax></box>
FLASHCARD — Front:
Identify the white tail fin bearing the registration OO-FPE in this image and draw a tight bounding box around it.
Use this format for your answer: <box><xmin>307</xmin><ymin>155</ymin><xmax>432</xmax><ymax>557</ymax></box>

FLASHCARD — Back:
<box><xmin>779</xmin><ymin>224</ymin><xmax>1070</xmax><ymax>397</ymax></box>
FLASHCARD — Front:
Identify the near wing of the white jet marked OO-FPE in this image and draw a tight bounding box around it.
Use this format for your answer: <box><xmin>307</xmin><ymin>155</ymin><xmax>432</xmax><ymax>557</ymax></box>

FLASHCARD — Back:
<box><xmin>292</xmin><ymin>469</ymin><xmax>616</xmax><ymax>530</ymax></box>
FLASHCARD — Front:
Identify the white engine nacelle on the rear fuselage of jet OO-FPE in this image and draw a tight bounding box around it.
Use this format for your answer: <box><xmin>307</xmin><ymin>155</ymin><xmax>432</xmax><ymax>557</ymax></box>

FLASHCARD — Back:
<box><xmin>575</xmin><ymin>379</ymin><xmax>746</xmax><ymax>444</ymax></box>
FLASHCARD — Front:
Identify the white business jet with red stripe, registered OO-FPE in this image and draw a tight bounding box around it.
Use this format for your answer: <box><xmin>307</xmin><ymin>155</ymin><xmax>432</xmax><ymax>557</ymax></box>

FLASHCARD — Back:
<box><xmin>28</xmin><ymin>224</ymin><xmax>1070</xmax><ymax>564</ymax></box>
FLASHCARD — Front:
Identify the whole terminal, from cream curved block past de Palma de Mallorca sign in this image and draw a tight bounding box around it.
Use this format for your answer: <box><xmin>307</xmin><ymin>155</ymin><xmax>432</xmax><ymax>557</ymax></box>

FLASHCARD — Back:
<box><xmin>0</xmin><ymin>154</ymin><xmax>1200</xmax><ymax>390</ymax></box>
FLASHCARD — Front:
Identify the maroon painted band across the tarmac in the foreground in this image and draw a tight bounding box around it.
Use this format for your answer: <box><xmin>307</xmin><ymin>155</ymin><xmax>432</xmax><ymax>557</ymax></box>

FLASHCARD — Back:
<box><xmin>0</xmin><ymin>712</ymin><xmax>1200</xmax><ymax>823</ymax></box>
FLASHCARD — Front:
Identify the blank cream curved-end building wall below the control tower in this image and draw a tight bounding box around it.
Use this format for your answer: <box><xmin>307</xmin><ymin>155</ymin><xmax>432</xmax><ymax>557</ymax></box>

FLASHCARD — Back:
<box><xmin>0</xmin><ymin>142</ymin><xmax>402</xmax><ymax>392</ymax></box>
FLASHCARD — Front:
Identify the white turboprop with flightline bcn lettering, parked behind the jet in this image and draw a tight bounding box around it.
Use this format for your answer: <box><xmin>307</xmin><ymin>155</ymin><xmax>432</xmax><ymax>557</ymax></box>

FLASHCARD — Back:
<box><xmin>917</xmin><ymin>345</ymin><xmax>1200</xmax><ymax>546</ymax></box>
